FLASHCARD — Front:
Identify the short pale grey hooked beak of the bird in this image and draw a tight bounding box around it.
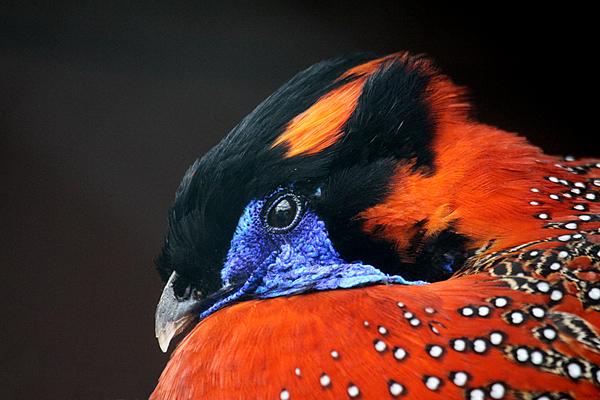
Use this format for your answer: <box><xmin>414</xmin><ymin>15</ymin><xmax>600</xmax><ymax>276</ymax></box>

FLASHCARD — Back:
<box><xmin>154</xmin><ymin>271</ymin><xmax>200</xmax><ymax>353</ymax></box>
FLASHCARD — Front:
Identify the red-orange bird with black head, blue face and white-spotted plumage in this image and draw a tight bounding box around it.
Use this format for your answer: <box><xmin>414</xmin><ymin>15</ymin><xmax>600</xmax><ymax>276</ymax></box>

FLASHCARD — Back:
<box><xmin>151</xmin><ymin>52</ymin><xmax>600</xmax><ymax>400</ymax></box>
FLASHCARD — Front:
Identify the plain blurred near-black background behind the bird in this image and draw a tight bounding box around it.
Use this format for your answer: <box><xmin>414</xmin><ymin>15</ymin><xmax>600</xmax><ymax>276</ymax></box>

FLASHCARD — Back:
<box><xmin>0</xmin><ymin>0</ymin><xmax>600</xmax><ymax>400</ymax></box>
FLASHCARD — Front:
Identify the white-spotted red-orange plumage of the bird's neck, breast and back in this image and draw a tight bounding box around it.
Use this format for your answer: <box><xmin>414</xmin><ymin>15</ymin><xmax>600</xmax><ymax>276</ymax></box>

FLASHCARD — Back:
<box><xmin>151</xmin><ymin>55</ymin><xmax>600</xmax><ymax>400</ymax></box>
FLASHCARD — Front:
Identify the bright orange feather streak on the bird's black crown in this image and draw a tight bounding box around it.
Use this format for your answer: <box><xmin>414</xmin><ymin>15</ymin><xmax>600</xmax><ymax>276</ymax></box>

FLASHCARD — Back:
<box><xmin>271</xmin><ymin>54</ymin><xmax>401</xmax><ymax>158</ymax></box>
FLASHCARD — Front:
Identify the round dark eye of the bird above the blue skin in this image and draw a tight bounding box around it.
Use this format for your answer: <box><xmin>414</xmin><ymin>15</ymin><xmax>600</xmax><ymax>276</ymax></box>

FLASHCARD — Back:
<box><xmin>265</xmin><ymin>192</ymin><xmax>302</xmax><ymax>233</ymax></box>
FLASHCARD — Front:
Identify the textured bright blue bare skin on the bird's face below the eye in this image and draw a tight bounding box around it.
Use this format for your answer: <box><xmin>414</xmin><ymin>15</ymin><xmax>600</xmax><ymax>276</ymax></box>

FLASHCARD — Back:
<box><xmin>200</xmin><ymin>189</ymin><xmax>427</xmax><ymax>319</ymax></box>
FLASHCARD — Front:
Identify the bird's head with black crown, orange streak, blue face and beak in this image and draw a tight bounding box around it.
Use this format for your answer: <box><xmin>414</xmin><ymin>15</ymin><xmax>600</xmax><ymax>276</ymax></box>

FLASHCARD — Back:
<box><xmin>156</xmin><ymin>53</ymin><xmax>536</xmax><ymax>351</ymax></box>
